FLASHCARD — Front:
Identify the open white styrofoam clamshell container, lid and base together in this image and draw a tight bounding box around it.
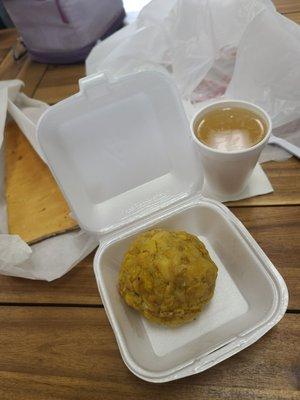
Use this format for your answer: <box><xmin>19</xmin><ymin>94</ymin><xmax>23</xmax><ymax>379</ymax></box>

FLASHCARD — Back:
<box><xmin>38</xmin><ymin>71</ymin><xmax>288</xmax><ymax>382</ymax></box>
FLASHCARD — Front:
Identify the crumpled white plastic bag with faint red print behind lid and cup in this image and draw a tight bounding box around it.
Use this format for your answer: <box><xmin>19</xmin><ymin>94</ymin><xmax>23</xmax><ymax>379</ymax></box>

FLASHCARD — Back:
<box><xmin>86</xmin><ymin>0</ymin><xmax>300</xmax><ymax>162</ymax></box>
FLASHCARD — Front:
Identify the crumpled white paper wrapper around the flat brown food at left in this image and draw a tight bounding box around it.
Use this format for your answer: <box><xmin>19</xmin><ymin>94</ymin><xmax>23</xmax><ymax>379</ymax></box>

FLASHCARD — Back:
<box><xmin>0</xmin><ymin>80</ymin><xmax>98</xmax><ymax>281</ymax></box>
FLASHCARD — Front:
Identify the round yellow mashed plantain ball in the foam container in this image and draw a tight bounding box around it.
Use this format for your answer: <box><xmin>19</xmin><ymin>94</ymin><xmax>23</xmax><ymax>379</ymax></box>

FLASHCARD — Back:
<box><xmin>119</xmin><ymin>229</ymin><xmax>218</xmax><ymax>327</ymax></box>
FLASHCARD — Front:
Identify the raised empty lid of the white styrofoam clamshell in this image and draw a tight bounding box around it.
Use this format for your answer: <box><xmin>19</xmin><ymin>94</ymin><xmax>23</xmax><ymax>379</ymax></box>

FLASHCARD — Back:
<box><xmin>38</xmin><ymin>71</ymin><xmax>203</xmax><ymax>234</ymax></box>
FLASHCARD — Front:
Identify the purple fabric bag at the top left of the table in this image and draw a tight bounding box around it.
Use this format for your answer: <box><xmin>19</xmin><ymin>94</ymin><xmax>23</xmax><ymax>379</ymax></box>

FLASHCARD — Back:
<box><xmin>4</xmin><ymin>0</ymin><xmax>125</xmax><ymax>63</ymax></box>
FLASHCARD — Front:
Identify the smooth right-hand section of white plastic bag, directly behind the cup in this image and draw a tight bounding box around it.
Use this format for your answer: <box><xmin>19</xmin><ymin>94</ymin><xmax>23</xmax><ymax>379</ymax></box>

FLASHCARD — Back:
<box><xmin>226</xmin><ymin>11</ymin><xmax>300</xmax><ymax>161</ymax></box>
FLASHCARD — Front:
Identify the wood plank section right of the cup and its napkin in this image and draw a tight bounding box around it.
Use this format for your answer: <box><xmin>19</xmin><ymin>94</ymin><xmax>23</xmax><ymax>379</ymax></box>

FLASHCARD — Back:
<box><xmin>226</xmin><ymin>157</ymin><xmax>300</xmax><ymax>207</ymax></box>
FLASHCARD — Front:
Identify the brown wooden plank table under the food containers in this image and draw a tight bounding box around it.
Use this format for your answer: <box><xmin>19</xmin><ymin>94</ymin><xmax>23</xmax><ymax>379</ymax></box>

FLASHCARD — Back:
<box><xmin>0</xmin><ymin>0</ymin><xmax>300</xmax><ymax>400</ymax></box>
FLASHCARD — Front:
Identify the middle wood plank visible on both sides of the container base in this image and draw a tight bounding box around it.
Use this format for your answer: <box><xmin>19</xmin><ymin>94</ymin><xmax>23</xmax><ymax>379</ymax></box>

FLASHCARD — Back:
<box><xmin>0</xmin><ymin>207</ymin><xmax>300</xmax><ymax>310</ymax></box>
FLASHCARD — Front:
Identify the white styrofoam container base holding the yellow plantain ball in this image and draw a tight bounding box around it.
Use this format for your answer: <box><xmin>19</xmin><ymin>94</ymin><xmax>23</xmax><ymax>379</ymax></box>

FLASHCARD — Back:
<box><xmin>94</xmin><ymin>199</ymin><xmax>288</xmax><ymax>382</ymax></box>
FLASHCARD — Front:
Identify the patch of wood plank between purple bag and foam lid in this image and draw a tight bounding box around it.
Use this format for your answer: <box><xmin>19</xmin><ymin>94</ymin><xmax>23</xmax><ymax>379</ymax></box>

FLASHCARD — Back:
<box><xmin>34</xmin><ymin>64</ymin><xmax>85</xmax><ymax>104</ymax></box>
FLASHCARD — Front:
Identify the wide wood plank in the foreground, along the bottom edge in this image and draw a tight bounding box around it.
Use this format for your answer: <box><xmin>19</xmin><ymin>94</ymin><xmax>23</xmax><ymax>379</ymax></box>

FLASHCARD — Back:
<box><xmin>0</xmin><ymin>307</ymin><xmax>300</xmax><ymax>400</ymax></box>
